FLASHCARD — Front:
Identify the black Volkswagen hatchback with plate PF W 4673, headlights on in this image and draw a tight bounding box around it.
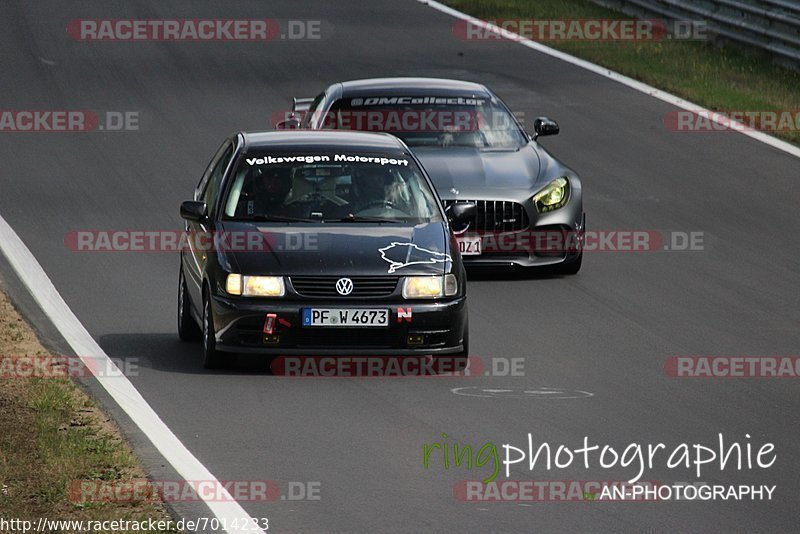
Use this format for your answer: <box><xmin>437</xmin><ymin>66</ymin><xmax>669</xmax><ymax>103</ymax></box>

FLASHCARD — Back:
<box><xmin>178</xmin><ymin>132</ymin><xmax>475</xmax><ymax>366</ymax></box>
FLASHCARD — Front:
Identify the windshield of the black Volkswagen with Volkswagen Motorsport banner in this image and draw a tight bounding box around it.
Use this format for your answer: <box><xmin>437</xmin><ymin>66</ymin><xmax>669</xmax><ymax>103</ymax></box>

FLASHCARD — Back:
<box><xmin>223</xmin><ymin>152</ymin><xmax>441</xmax><ymax>224</ymax></box>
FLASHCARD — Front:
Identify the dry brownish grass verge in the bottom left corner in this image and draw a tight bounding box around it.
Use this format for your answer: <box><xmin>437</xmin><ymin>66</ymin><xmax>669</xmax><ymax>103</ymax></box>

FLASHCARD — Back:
<box><xmin>0</xmin><ymin>293</ymin><xmax>175</xmax><ymax>532</ymax></box>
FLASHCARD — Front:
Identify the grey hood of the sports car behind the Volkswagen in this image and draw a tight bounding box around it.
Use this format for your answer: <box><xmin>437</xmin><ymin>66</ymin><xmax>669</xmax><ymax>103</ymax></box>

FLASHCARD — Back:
<box><xmin>412</xmin><ymin>144</ymin><xmax>541</xmax><ymax>199</ymax></box>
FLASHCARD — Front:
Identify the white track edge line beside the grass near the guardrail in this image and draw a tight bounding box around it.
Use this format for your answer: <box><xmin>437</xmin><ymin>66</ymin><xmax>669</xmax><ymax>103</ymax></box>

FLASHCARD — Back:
<box><xmin>417</xmin><ymin>0</ymin><xmax>800</xmax><ymax>158</ymax></box>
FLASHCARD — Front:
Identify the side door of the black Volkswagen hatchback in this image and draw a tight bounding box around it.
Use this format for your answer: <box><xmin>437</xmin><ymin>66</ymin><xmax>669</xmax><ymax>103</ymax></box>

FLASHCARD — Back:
<box><xmin>181</xmin><ymin>139</ymin><xmax>234</xmax><ymax>312</ymax></box>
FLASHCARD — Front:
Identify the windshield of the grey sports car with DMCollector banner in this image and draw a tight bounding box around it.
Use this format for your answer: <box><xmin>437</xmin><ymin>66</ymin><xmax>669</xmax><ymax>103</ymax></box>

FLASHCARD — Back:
<box><xmin>322</xmin><ymin>96</ymin><xmax>526</xmax><ymax>149</ymax></box>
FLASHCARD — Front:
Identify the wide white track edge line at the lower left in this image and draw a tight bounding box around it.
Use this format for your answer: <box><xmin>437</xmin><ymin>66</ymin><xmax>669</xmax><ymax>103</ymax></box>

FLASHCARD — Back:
<box><xmin>0</xmin><ymin>217</ymin><xmax>264</xmax><ymax>534</ymax></box>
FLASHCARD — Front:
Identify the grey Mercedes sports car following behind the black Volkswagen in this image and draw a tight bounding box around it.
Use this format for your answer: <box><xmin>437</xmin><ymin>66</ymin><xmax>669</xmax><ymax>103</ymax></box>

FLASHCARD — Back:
<box><xmin>277</xmin><ymin>78</ymin><xmax>585</xmax><ymax>274</ymax></box>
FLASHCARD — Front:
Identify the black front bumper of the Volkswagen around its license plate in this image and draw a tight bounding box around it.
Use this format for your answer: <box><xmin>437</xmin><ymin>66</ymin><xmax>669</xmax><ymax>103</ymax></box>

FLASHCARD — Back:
<box><xmin>211</xmin><ymin>295</ymin><xmax>467</xmax><ymax>356</ymax></box>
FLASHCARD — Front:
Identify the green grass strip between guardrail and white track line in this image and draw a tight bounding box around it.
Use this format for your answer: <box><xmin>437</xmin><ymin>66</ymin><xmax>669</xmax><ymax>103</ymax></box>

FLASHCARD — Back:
<box><xmin>442</xmin><ymin>0</ymin><xmax>800</xmax><ymax>144</ymax></box>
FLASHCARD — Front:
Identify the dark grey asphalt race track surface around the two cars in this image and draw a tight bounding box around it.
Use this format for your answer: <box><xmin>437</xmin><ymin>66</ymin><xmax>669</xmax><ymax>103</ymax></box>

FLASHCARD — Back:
<box><xmin>0</xmin><ymin>0</ymin><xmax>800</xmax><ymax>532</ymax></box>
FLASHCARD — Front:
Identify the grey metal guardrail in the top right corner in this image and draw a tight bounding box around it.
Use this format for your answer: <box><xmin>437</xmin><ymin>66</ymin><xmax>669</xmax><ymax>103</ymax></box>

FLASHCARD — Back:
<box><xmin>592</xmin><ymin>0</ymin><xmax>800</xmax><ymax>70</ymax></box>
